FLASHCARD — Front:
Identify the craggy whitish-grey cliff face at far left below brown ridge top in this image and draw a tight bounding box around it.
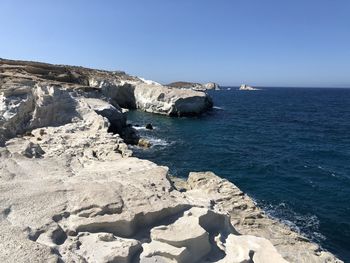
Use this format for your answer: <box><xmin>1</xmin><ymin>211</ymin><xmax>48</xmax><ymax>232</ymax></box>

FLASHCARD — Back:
<box><xmin>0</xmin><ymin>80</ymin><xmax>79</xmax><ymax>145</ymax></box>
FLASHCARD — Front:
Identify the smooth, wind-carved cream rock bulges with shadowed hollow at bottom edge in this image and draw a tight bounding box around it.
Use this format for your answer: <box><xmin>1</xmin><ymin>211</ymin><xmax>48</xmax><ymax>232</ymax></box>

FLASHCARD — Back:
<box><xmin>140</xmin><ymin>208</ymin><xmax>287</xmax><ymax>263</ymax></box>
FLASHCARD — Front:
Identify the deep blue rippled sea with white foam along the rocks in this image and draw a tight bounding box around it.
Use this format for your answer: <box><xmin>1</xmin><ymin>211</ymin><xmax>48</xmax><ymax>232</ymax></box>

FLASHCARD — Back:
<box><xmin>128</xmin><ymin>87</ymin><xmax>350</xmax><ymax>262</ymax></box>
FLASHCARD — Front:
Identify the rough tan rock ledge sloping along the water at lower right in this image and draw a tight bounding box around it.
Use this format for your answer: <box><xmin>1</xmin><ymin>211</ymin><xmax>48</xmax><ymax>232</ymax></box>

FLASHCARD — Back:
<box><xmin>171</xmin><ymin>172</ymin><xmax>342</xmax><ymax>263</ymax></box>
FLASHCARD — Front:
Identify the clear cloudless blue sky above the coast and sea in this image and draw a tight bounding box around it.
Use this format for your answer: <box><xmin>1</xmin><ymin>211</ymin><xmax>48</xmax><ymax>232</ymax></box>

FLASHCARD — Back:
<box><xmin>0</xmin><ymin>0</ymin><xmax>350</xmax><ymax>87</ymax></box>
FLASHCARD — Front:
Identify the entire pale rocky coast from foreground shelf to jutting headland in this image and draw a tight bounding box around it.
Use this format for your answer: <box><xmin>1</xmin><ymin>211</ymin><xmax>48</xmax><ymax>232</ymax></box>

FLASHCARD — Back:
<box><xmin>0</xmin><ymin>59</ymin><xmax>341</xmax><ymax>263</ymax></box>
